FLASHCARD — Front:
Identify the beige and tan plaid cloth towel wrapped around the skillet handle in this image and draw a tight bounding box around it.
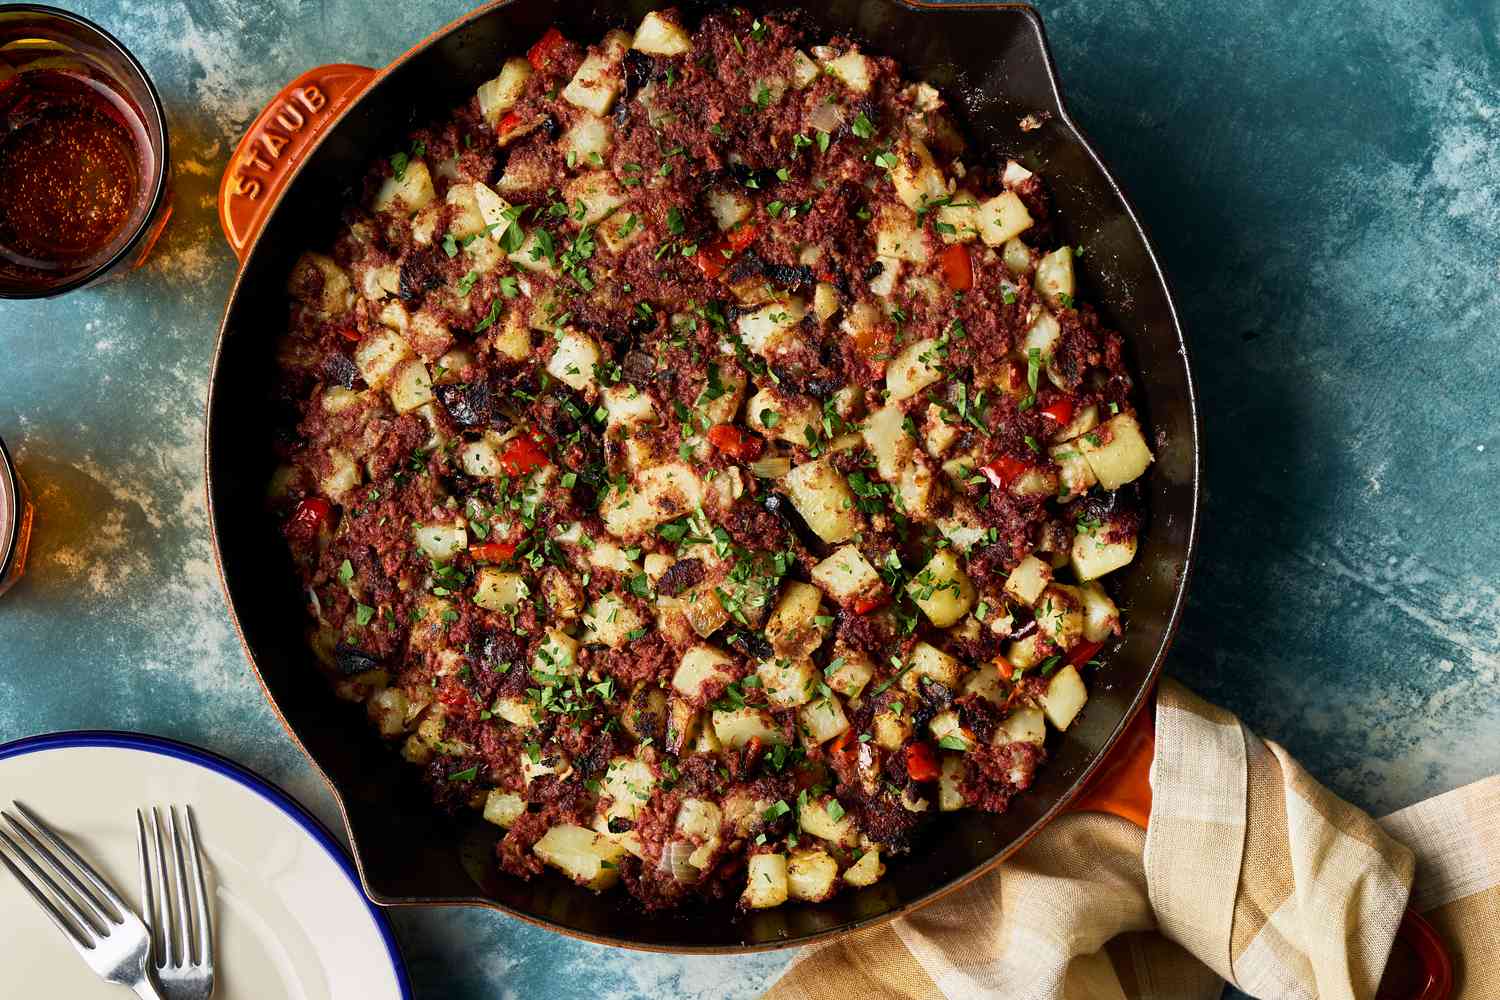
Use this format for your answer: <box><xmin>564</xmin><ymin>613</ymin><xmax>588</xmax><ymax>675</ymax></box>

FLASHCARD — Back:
<box><xmin>767</xmin><ymin>681</ymin><xmax>1500</xmax><ymax>1000</ymax></box>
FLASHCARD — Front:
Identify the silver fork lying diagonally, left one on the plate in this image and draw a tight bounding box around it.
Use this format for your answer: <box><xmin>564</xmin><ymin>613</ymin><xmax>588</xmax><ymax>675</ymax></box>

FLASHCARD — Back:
<box><xmin>0</xmin><ymin>802</ymin><xmax>164</xmax><ymax>1000</ymax></box>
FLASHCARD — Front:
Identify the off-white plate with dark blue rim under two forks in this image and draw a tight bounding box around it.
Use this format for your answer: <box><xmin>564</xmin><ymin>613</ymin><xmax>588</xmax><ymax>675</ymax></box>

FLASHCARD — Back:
<box><xmin>0</xmin><ymin>733</ymin><xmax>411</xmax><ymax>1000</ymax></box>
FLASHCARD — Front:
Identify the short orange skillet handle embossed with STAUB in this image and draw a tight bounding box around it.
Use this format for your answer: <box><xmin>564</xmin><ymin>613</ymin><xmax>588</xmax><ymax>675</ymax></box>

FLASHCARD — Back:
<box><xmin>219</xmin><ymin>63</ymin><xmax>377</xmax><ymax>262</ymax></box>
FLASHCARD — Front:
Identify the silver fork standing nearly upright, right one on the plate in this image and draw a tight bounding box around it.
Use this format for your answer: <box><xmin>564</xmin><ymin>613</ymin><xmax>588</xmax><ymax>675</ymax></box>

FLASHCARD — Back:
<box><xmin>135</xmin><ymin>805</ymin><xmax>213</xmax><ymax>1000</ymax></box>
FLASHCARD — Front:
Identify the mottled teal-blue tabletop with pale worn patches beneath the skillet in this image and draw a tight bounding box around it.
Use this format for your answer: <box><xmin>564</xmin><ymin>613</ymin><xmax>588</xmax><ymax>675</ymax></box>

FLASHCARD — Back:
<box><xmin>0</xmin><ymin>0</ymin><xmax>1500</xmax><ymax>1000</ymax></box>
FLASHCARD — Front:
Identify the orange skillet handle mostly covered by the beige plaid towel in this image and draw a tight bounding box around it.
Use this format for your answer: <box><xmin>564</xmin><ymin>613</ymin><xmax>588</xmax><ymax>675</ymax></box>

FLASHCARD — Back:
<box><xmin>1068</xmin><ymin>696</ymin><xmax>1454</xmax><ymax>1000</ymax></box>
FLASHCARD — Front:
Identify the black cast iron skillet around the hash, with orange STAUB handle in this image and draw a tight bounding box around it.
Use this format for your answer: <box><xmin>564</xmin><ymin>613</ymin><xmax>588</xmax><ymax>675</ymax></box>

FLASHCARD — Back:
<box><xmin>207</xmin><ymin>0</ymin><xmax>1199</xmax><ymax>952</ymax></box>
